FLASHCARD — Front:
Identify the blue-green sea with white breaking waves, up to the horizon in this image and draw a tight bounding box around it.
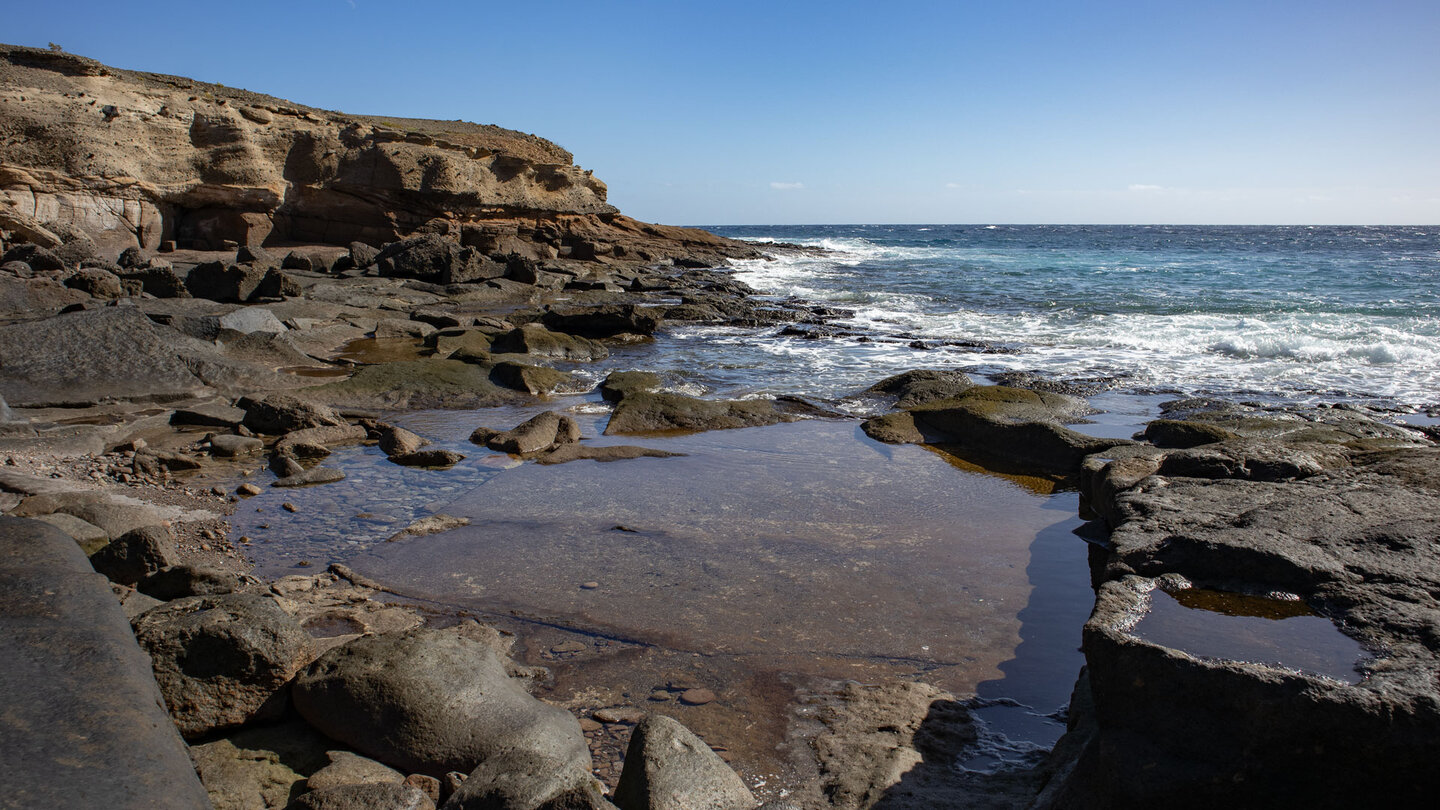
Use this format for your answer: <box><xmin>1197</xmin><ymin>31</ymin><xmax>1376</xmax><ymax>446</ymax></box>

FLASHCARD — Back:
<box><xmin>688</xmin><ymin>225</ymin><xmax>1440</xmax><ymax>409</ymax></box>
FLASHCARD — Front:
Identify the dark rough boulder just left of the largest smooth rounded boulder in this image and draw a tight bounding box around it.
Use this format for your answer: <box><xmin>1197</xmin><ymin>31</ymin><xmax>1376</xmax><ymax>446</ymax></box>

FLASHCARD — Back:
<box><xmin>134</xmin><ymin>594</ymin><xmax>310</xmax><ymax>739</ymax></box>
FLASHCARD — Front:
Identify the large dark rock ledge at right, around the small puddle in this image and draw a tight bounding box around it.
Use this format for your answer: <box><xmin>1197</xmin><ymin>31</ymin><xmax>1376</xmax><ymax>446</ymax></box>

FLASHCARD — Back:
<box><xmin>1044</xmin><ymin>444</ymin><xmax>1440</xmax><ymax>809</ymax></box>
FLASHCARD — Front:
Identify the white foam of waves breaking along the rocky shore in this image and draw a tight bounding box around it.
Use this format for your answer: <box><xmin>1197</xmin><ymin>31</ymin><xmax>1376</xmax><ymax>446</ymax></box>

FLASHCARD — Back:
<box><xmin>720</xmin><ymin>238</ymin><xmax>1440</xmax><ymax>404</ymax></box>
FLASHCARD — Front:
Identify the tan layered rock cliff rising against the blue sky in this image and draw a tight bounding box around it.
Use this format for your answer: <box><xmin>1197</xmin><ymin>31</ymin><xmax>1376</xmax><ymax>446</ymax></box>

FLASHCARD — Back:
<box><xmin>0</xmin><ymin>45</ymin><xmax>727</xmax><ymax>259</ymax></box>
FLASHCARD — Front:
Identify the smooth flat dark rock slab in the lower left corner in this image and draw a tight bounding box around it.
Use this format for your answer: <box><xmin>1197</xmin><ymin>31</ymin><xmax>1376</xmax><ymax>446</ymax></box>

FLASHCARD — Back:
<box><xmin>0</xmin><ymin>517</ymin><xmax>210</xmax><ymax>809</ymax></box>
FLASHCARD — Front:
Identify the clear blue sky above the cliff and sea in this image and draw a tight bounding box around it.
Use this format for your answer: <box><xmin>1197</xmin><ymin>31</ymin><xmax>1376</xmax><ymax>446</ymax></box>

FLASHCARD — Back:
<box><xmin>0</xmin><ymin>0</ymin><xmax>1440</xmax><ymax>225</ymax></box>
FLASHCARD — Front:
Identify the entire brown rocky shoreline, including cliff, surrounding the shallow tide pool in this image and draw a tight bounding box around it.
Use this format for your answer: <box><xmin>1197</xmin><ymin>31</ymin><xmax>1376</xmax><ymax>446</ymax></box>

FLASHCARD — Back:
<box><xmin>0</xmin><ymin>41</ymin><xmax>1440</xmax><ymax>810</ymax></box>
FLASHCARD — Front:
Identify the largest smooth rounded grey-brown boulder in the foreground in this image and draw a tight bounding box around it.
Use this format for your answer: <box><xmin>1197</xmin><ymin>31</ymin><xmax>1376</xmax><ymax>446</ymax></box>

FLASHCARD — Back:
<box><xmin>295</xmin><ymin>630</ymin><xmax>590</xmax><ymax>777</ymax></box>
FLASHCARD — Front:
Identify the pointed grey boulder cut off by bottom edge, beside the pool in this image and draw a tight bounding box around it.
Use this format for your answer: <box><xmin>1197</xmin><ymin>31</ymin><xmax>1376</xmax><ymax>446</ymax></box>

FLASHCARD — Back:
<box><xmin>615</xmin><ymin>715</ymin><xmax>759</xmax><ymax>810</ymax></box>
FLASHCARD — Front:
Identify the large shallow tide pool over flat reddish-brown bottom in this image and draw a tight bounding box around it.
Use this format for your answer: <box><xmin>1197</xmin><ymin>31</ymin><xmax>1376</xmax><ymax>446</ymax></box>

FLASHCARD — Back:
<box><xmin>286</xmin><ymin>414</ymin><xmax>1092</xmax><ymax>784</ymax></box>
